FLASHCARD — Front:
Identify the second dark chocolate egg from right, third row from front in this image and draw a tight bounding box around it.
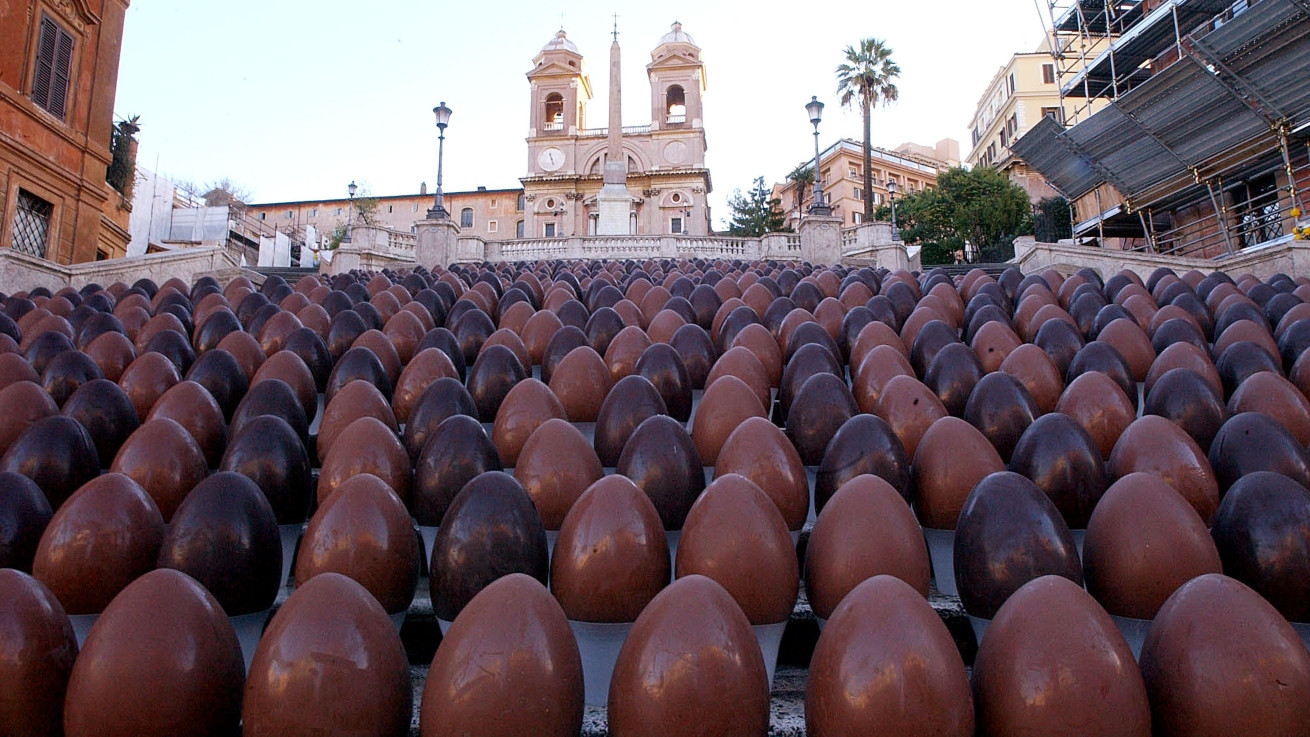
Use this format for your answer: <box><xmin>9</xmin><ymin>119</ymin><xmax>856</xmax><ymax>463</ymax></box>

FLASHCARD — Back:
<box><xmin>1010</xmin><ymin>412</ymin><xmax>1110</xmax><ymax>530</ymax></box>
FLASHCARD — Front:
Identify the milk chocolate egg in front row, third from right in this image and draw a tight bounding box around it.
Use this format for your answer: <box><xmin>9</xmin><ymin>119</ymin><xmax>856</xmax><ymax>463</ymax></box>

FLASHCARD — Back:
<box><xmin>806</xmin><ymin>576</ymin><xmax>973</xmax><ymax>737</ymax></box>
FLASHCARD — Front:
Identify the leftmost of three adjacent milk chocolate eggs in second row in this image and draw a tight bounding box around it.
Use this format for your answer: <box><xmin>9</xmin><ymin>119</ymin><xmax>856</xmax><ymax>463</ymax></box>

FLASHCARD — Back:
<box><xmin>550</xmin><ymin>475</ymin><xmax>672</xmax><ymax>622</ymax></box>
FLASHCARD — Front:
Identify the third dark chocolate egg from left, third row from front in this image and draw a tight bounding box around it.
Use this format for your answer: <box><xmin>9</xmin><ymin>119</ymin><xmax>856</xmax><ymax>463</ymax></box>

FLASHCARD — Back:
<box><xmin>414</xmin><ymin>413</ymin><xmax>502</xmax><ymax>525</ymax></box>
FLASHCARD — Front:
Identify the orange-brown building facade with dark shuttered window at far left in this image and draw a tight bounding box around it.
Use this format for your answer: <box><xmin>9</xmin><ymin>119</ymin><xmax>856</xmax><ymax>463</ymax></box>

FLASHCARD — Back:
<box><xmin>0</xmin><ymin>0</ymin><xmax>130</xmax><ymax>264</ymax></box>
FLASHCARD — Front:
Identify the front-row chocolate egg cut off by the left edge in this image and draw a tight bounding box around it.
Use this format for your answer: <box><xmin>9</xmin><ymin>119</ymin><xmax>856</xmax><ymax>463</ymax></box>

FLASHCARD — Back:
<box><xmin>0</xmin><ymin>568</ymin><xmax>77</xmax><ymax>737</ymax></box>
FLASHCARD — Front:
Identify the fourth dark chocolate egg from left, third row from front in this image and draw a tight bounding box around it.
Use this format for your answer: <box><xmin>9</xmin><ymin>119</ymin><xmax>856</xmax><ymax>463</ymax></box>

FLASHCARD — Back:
<box><xmin>617</xmin><ymin>415</ymin><xmax>705</xmax><ymax>530</ymax></box>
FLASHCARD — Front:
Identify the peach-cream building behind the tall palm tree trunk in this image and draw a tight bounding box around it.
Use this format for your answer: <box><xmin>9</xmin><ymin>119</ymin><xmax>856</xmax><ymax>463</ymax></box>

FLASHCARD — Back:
<box><xmin>773</xmin><ymin>139</ymin><xmax>960</xmax><ymax>230</ymax></box>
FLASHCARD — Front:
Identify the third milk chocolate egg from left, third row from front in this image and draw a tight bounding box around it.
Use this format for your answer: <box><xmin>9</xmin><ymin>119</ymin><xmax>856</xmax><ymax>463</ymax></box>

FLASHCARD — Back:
<box><xmin>514</xmin><ymin>421</ymin><xmax>607</xmax><ymax>530</ymax></box>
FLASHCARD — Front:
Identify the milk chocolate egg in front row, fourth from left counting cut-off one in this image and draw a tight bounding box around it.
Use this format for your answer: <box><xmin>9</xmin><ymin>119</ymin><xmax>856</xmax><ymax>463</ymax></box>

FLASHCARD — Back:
<box><xmin>419</xmin><ymin>573</ymin><xmax>584</xmax><ymax>737</ymax></box>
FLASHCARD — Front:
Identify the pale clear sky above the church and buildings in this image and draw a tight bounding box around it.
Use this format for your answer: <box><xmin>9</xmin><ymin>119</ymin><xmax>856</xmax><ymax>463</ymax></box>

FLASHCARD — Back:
<box><xmin>115</xmin><ymin>0</ymin><xmax>1045</xmax><ymax>228</ymax></box>
